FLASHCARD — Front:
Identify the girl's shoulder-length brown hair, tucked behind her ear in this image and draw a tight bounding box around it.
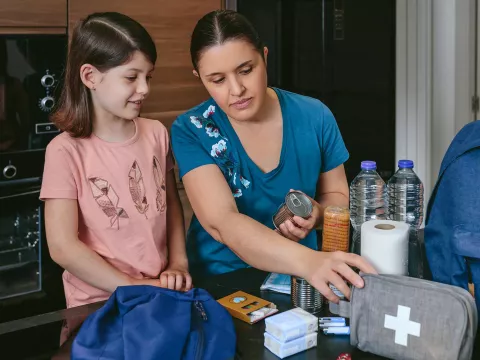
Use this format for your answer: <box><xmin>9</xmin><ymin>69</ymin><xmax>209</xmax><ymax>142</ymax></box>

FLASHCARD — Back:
<box><xmin>51</xmin><ymin>12</ymin><xmax>157</xmax><ymax>137</ymax></box>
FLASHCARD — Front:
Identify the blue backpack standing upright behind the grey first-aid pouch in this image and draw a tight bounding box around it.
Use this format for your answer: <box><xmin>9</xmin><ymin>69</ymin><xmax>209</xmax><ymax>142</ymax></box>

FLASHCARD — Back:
<box><xmin>425</xmin><ymin>121</ymin><xmax>480</xmax><ymax>311</ymax></box>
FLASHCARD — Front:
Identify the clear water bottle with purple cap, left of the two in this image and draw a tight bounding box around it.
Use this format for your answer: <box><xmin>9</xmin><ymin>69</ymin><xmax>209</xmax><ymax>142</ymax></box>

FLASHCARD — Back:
<box><xmin>350</xmin><ymin>161</ymin><xmax>387</xmax><ymax>255</ymax></box>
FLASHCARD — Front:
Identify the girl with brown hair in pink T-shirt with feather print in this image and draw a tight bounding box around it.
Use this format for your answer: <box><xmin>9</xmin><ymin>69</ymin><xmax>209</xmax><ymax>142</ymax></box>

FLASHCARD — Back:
<box><xmin>40</xmin><ymin>12</ymin><xmax>191</xmax><ymax>307</ymax></box>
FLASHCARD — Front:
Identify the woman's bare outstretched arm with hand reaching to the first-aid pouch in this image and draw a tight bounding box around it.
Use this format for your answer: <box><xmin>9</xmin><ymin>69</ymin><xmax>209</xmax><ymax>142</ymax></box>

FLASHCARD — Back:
<box><xmin>183</xmin><ymin>165</ymin><xmax>375</xmax><ymax>301</ymax></box>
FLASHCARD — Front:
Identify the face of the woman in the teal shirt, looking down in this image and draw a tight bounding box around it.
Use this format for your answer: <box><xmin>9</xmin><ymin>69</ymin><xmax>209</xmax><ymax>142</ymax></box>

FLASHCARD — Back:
<box><xmin>198</xmin><ymin>40</ymin><xmax>268</xmax><ymax>121</ymax></box>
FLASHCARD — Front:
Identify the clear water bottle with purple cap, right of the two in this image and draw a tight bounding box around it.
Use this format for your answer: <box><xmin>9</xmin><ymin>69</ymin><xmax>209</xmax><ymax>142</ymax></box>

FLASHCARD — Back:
<box><xmin>387</xmin><ymin>160</ymin><xmax>423</xmax><ymax>277</ymax></box>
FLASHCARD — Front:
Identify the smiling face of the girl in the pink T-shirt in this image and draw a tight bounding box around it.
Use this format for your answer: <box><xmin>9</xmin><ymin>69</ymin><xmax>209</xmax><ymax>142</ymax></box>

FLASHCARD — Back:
<box><xmin>82</xmin><ymin>51</ymin><xmax>154</xmax><ymax>120</ymax></box>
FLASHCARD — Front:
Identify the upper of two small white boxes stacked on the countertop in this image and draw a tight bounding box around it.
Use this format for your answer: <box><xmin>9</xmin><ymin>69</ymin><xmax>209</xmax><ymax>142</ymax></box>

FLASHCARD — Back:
<box><xmin>265</xmin><ymin>308</ymin><xmax>318</xmax><ymax>342</ymax></box>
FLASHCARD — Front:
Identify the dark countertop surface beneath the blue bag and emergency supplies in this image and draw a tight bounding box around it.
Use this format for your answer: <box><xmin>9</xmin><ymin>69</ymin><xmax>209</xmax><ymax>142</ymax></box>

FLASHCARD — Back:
<box><xmin>0</xmin><ymin>268</ymin><xmax>379</xmax><ymax>360</ymax></box>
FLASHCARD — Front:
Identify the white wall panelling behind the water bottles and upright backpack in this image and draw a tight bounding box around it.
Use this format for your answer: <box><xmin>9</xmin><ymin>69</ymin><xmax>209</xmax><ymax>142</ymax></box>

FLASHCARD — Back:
<box><xmin>396</xmin><ymin>0</ymin><xmax>478</xmax><ymax>211</ymax></box>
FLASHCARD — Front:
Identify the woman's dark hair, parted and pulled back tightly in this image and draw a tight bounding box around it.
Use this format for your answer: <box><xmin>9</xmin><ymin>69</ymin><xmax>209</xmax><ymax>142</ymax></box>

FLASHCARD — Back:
<box><xmin>190</xmin><ymin>10</ymin><xmax>264</xmax><ymax>71</ymax></box>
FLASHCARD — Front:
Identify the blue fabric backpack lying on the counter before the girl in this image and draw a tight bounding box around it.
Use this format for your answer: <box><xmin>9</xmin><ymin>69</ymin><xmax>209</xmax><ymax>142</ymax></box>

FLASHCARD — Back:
<box><xmin>71</xmin><ymin>286</ymin><xmax>236</xmax><ymax>360</ymax></box>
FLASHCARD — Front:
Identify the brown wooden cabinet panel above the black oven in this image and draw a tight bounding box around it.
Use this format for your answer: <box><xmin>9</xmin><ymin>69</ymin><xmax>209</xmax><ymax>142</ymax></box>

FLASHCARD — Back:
<box><xmin>0</xmin><ymin>0</ymin><xmax>67</xmax><ymax>28</ymax></box>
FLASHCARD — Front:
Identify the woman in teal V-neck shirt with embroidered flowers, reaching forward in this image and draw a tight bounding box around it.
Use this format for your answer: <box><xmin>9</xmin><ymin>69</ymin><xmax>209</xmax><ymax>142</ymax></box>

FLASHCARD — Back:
<box><xmin>172</xmin><ymin>10</ymin><xmax>374</xmax><ymax>301</ymax></box>
